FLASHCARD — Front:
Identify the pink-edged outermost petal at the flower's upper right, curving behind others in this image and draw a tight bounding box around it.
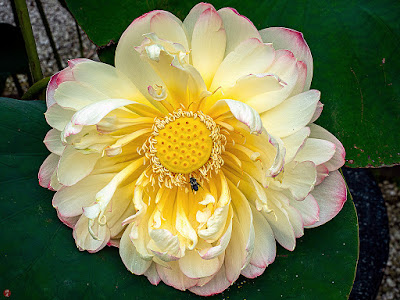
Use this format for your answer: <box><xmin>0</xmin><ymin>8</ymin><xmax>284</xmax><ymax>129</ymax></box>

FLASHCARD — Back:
<box><xmin>260</xmin><ymin>27</ymin><xmax>313</xmax><ymax>91</ymax></box>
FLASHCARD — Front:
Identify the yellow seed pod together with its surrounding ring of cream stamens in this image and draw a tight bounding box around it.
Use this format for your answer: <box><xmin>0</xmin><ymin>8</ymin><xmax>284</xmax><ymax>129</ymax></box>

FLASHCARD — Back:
<box><xmin>143</xmin><ymin>109</ymin><xmax>226</xmax><ymax>188</ymax></box>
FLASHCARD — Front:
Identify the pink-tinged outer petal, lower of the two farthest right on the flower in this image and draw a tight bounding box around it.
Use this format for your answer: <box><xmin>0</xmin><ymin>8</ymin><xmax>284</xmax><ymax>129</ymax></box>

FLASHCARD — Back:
<box><xmin>308</xmin><ymin>171</ymin><xmax>347</xmax><ymax>228</ymax></box>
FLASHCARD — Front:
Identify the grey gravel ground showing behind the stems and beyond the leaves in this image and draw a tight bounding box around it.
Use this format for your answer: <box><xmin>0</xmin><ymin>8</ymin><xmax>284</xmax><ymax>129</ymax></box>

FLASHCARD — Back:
<box><xmin>0</xmin><ymin>0</ymin><xmax>400</xmax><ymax>300</ymax></box>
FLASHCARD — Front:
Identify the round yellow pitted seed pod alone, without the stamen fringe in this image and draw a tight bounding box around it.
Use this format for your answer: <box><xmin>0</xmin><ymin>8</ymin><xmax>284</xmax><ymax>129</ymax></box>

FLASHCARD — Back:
<box><xmin>155</xmin><ymin>117</ymin><xmax>213</xmax><ymax>174</ymax></box>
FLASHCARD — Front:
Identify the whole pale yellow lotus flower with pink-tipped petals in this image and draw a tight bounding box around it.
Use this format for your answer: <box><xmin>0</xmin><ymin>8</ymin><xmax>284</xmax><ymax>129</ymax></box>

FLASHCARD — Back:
<box><xmin>39</xmin><ymin>3</ymin><xmax>346</xmax><ymax>295</ymax></box>
